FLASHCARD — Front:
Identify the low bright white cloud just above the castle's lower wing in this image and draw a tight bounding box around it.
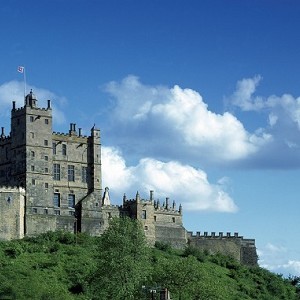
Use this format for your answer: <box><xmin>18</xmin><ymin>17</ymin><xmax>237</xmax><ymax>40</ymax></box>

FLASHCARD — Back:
<box><xmin>102</xmin><ymin>147</ymin><xmax>237</xmax><ymax>212</ymax></box>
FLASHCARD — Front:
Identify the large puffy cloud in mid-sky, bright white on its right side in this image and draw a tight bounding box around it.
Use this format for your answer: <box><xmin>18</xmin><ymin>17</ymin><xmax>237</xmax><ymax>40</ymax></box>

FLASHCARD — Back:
<box><xmin>106</xmin><ymin>76</ymin><xmax>271</xmax><ymax>162</ymax></box>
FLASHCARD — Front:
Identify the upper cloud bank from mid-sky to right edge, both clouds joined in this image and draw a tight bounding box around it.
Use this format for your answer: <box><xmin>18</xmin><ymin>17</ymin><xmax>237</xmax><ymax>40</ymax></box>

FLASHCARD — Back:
<box><xmin>106</xmin><ymin>76</ymin><xmax>300</xmax><ymax>169</ymax></box>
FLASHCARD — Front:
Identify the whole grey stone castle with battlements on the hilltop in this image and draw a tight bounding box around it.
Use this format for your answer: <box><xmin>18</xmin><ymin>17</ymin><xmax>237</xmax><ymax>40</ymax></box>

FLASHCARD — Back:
<box><xmin>0</xmin><ymin>91</ymin><xmax>257</xmax><ymax>265</ymax></box>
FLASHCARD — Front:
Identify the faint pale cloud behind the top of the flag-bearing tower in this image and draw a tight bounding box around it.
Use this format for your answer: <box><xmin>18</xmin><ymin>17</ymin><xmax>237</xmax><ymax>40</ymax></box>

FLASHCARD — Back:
<box><xmin>0</xmin><ymin>80</ymin><xmax>67</xmax><ymax>124</ymax></box>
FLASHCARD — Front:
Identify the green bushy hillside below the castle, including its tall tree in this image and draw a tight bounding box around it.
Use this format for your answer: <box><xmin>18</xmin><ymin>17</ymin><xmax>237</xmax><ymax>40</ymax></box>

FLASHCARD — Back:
<box><xmin>0</xmin><ymin>218</ymin><xmax>300</xmax><ymax>300</ymax></box>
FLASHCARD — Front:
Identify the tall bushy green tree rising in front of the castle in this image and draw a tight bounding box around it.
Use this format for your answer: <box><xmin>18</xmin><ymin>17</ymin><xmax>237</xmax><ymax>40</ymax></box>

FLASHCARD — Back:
<box><xmin>90</xmin><ymin>218</ymin><xmax>150</xmax><ymax>300</ymax></box>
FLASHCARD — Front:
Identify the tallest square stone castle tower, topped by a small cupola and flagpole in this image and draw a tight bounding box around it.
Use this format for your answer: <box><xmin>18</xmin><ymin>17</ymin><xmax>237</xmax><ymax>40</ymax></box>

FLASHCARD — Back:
<box><xmin>8</xmin><ymin>91</ymin><xmax>55</xmax><ymax>234</ymax></box>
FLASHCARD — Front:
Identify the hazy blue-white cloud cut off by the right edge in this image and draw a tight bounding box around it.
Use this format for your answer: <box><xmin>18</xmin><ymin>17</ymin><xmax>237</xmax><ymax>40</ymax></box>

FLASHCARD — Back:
<box><xmin>228</xmin><ymin>76</ymin><xmax>300</xmax><ymax>168</ymax></box>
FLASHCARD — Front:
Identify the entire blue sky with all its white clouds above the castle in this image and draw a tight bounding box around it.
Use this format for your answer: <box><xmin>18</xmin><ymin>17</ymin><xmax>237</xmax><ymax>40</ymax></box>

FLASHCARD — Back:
<box><xmin>0</xmin><ymin>0</ymin><xmax>300</xmax><ymax>275</ymax></box>
